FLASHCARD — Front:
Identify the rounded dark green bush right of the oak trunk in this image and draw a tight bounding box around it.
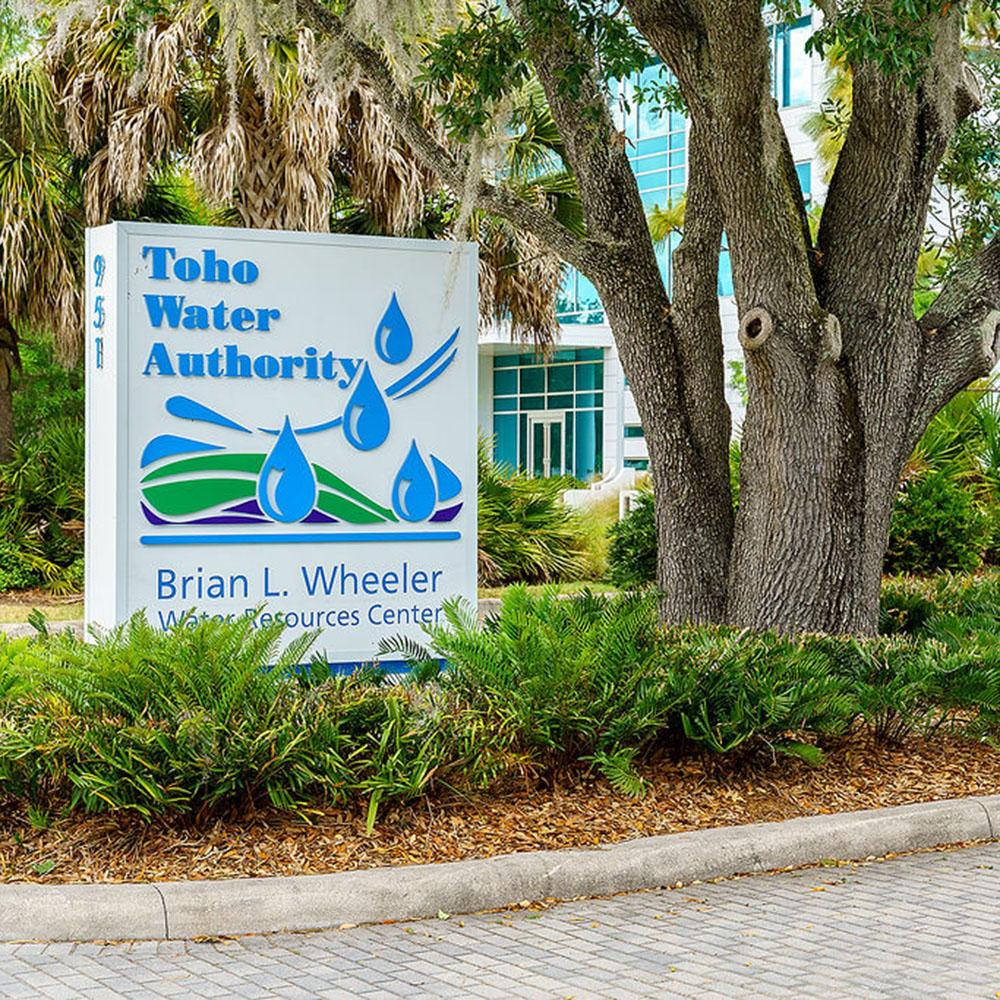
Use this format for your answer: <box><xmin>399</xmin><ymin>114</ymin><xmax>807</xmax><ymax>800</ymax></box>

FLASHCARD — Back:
<box><xmin>885</xmin><ymin>469</ymin><xmax>992</xmax><ymax>573</ymax></box>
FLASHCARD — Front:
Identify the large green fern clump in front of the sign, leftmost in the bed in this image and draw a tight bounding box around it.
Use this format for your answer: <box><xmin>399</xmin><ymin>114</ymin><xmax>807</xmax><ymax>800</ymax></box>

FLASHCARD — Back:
<box><xmin>0</xmin><ymin>617</ymin><xmax>504</xmax><ymax>822</ymax></box>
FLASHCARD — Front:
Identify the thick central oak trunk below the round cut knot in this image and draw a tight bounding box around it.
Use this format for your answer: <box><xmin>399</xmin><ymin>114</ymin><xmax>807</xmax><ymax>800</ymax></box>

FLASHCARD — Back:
<box><xmin>727</xmin><ymin>309</ymin><xmax>877</xmax><ymax>632</ymax></box>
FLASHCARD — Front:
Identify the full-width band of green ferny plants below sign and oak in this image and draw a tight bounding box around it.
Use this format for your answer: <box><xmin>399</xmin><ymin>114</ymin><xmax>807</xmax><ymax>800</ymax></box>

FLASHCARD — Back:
<box><xmin>0</xmin><ymin>577</ymin><xmax>1000</xmax><ymax>828</ymax></box>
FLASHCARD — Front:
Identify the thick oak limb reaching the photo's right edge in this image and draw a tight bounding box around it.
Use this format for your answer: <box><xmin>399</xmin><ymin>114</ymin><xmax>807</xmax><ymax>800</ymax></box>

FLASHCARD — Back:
<box><xmin>911</xmin><ymin>236</ymin><xmax>1000</xmax><ymax>441</ymax></box>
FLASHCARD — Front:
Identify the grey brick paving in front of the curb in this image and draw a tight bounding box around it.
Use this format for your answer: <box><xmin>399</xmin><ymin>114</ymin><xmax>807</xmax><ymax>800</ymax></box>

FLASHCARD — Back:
<box><xmin>0</xmin><ymin>844</ymin><xmax>1000</xmax><ymax>1000</ymax></box>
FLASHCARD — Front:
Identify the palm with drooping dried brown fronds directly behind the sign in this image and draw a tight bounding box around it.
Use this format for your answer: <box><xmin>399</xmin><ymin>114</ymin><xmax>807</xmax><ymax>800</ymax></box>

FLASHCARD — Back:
<box><xmin>49</xmin><ymin>0</ymin><xmax>582</xmax><ymax>345</ymax></box>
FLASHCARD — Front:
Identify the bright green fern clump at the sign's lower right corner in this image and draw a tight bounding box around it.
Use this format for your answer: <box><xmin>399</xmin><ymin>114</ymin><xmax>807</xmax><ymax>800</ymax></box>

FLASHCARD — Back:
<box><xmin>427</xmin><ymin>587</ymin><xmax>675</xmax><ymax>780</ymax></box>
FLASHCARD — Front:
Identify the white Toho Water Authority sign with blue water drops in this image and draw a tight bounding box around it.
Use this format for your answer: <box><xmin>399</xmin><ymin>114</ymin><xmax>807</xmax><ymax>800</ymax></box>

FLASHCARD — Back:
<box><xmin>86</xmin><ymin>223</ymin><xmax>477</xmax><ymax>664</ymax></box>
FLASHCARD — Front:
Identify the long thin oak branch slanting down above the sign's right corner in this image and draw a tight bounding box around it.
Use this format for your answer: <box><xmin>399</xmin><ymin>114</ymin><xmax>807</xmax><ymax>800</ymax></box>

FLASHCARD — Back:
<box><xmin>296</xmin><ymin>0</ymin><xmax>606</xmax><ymax>270</ymax></box>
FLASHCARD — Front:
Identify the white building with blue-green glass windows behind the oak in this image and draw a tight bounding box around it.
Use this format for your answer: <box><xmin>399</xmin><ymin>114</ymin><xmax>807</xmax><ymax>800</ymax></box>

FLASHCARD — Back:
<box><xmin>479</xmin><ymin>12</ymin><xmax>826</xmax><ymax>483</ymax></box>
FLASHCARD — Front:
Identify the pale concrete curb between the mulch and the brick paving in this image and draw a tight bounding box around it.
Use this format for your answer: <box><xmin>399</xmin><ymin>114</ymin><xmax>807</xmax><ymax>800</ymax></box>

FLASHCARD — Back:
<box><xmin>0</xmin><ymin>795</ymin><xmax>1000</xmax><ymax>941</ymax></box>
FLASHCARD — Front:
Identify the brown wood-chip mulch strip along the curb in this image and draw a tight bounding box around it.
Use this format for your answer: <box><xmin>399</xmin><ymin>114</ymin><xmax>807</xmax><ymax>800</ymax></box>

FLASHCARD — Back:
<box><xmin>0</xmin><ymin>736</ymin><xmax>1000</xmax><ymax>883</ymax></box>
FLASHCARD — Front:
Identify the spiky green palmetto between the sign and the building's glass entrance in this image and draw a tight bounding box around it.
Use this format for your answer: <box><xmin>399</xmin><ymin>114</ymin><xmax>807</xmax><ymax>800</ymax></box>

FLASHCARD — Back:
<box><xmin>479</xmin><ymin>440</ymin><xmax>586</xmax><ymax>586</ymax></box>
